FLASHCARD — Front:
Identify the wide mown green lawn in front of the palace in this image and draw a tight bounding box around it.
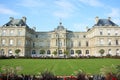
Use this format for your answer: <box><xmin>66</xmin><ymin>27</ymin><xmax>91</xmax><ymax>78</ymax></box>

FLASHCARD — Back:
<box><xmin>0</xmin><ymin>59</ymin><xmax>120</xmax><ymax>75</ymax></box>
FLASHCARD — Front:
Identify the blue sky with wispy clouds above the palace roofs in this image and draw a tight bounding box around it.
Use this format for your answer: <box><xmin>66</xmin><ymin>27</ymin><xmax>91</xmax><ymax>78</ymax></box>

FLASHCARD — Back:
<box><xmin>0</xmin><ymin>0</ymin><xmax>120</xmax><ymax>31</ymax></box>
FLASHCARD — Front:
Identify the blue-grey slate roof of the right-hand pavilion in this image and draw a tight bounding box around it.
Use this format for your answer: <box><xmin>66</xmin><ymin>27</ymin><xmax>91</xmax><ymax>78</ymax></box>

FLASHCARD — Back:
<box><xmin>95</xmin><ymin>19</ymin><xmax>118</xmax><ymax>26</ymax></box>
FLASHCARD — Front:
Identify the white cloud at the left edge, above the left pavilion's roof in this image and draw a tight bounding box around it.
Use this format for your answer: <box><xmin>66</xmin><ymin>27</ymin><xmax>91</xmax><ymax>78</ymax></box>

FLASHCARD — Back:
<box><xmin>0</xmin><ymin>4</ymin><xmax>18</xmax><ymax>15</ymax></box>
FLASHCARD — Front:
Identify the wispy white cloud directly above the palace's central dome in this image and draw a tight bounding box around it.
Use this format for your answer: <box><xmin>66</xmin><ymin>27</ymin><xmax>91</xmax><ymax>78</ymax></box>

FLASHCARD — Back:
<box><xmin>53</xmin><ymin>0</ymin><xmax>76</xmax><ymax>18</ymax></box>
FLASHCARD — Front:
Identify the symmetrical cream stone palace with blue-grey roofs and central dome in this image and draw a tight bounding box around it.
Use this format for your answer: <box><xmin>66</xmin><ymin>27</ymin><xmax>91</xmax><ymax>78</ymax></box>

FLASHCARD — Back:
<box><xmin>0</xmin><ymin>17</ymin><xmax>120</xmax><ymax>57</ymax></box>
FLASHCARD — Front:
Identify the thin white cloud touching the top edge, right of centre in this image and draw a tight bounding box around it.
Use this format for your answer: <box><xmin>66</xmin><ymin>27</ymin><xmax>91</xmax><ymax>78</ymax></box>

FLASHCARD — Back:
<box><xmin>79</xmin><ymin>0</ymin><xmax>103</xmax><ymax>7</ymax></box>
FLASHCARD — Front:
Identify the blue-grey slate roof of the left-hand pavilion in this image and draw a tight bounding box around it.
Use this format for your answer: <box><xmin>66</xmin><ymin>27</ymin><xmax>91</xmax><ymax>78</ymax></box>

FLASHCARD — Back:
<box><xmin>3</xmin><ymin>19</ymin><xmax>28</xmax><ymax>27</ymax></box>
